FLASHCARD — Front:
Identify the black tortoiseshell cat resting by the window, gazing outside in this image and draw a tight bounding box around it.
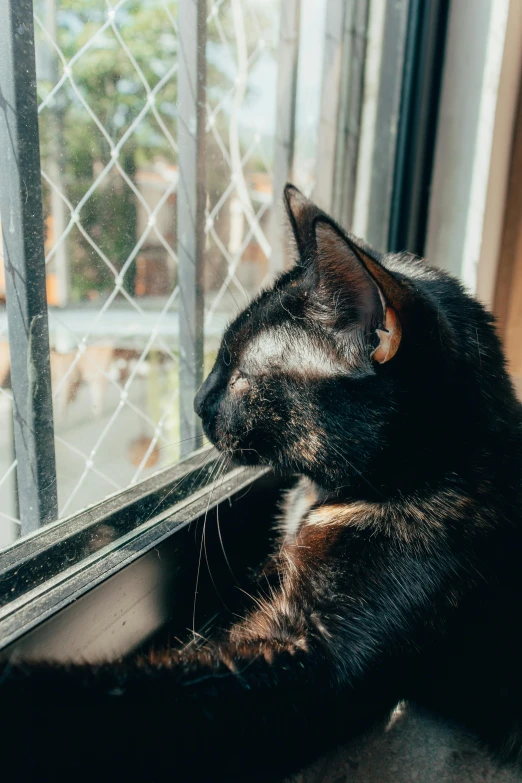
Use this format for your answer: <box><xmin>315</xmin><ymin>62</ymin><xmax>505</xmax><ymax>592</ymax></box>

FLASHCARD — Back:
<box><xmin>0</xmin><ymin>185</ymin><xmax>522</xmax><ymax>783</ymax></box>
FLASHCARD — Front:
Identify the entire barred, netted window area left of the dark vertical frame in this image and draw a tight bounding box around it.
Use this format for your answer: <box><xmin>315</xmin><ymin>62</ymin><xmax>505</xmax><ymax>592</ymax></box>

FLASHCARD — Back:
<box><xmin>0</xmin><ymin>0</ymin><xmax>437</xmax><ymax>545</ymax></box>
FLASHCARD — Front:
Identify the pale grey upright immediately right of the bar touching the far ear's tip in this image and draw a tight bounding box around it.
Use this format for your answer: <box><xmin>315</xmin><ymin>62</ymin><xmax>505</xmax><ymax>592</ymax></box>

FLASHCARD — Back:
<box><xmin>314</xmin><ymin>0</ymin><xmax>346</xmax><ymax>212</ymax></box>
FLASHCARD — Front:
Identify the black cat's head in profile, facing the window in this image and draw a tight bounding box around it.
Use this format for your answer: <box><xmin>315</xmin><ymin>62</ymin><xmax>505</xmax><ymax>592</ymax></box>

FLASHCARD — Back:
<box><xmin>195</xmin><ymin>186</ymin><xmax>510</xmax><ymax>494</ymax></box>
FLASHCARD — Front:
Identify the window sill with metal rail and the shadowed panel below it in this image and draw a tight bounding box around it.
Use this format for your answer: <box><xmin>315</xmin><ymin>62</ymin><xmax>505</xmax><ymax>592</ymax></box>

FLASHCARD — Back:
<box><xmin>0</xmin><ymin>448</ymin><xmax>281</xmax><ymax>661</ymax></box>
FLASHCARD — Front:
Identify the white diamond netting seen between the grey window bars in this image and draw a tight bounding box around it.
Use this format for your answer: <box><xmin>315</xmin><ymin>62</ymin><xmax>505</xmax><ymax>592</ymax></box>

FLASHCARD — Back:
<box><xmin>0</xmin><ymin>0</ymin><xmax>279</xmax><ymax>543</ymax></box>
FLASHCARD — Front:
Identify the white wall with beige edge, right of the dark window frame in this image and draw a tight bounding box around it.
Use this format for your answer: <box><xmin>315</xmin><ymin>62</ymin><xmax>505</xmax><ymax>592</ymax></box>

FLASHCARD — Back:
<box><xmin>426</xmin><ymin>0</ymin><xmax>522</xmax><ymax>304</ymax></box>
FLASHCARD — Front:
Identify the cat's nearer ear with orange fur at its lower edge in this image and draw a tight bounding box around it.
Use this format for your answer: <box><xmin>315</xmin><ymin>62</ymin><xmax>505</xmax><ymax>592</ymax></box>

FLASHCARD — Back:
<box><xmin>311</xmin><ymin>217</ymin><xmax>408</xmax><ymax>364</ymax></box>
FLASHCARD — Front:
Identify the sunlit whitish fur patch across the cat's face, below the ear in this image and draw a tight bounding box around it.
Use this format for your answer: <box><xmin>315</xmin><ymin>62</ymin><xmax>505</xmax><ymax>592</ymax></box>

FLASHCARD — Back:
<box><xmin>241</xmin><ymin>328</ymin><xmax>350</xmax><ymax>378</ymax></box>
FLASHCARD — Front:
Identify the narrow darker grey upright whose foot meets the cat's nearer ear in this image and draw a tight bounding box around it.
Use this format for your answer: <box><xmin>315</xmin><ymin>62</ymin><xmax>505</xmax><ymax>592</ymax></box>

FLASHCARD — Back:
<box><xmin>332</xmin><ymin>0</ymin><xmax>369</xmax><ymax>230</ymax></box>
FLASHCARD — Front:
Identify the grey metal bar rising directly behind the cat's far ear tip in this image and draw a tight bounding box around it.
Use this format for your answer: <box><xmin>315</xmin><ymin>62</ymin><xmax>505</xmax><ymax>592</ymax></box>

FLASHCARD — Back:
<box><xmin>270</xmin><ymin>0</ymin><xmax>301</xmax><ymax>276</ymax></box>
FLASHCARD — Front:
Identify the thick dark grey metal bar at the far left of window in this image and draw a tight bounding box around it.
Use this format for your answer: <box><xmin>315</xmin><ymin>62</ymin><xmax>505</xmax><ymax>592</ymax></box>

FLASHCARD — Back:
<box><xmin>0</xmin><ymin>0</ymin><xmax>58</xmax><ymax>534</ymax></box>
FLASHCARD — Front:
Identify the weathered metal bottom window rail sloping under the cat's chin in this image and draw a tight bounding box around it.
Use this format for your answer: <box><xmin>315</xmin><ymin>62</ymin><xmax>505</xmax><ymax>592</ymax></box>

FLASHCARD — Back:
<box><xmin>0</xmin><ymin>446</ymin><xmax>267</xmax><ymax>650</ymax></box>
